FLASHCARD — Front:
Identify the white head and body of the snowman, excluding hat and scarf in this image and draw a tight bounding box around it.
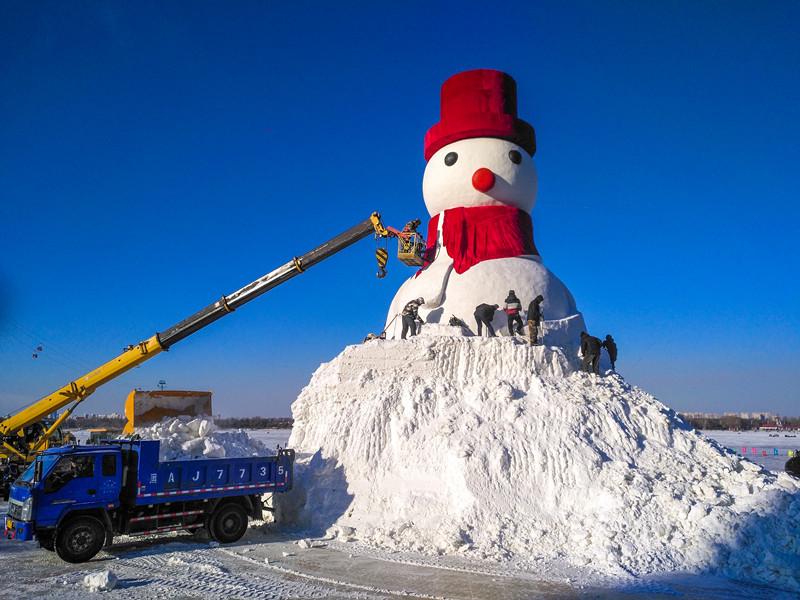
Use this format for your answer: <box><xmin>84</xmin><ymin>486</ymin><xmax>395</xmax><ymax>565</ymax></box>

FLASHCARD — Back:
<box><xmin>387</xmin><ymin>137</ymin><xmax>584</xmax><ymax>349</ymax></box>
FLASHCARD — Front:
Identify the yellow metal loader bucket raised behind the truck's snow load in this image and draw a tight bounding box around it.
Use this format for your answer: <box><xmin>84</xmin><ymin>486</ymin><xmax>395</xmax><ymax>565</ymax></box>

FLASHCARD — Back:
<box><xmin>122</xmin><ymin>390</ymin><xmax>213</xmax><ymax>434</ymax></box>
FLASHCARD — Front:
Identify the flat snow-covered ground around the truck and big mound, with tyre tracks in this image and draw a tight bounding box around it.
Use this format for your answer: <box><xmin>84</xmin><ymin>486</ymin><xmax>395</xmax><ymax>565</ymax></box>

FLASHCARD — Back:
<box><xmin>0</xmin><ymin>418</ymin><xmax>796</xmax><ymax>600</ymax></box>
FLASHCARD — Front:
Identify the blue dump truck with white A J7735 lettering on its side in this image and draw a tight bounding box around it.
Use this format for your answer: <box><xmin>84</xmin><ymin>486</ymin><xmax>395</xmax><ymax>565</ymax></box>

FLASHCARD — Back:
<box><xmin>4</xmin><ymin>440</ymin><xmax>294</xmax><ymax>563</ymax></box>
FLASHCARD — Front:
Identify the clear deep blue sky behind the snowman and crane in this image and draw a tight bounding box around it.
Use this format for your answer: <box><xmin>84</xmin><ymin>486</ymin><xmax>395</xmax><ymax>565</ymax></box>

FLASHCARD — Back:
<box><xmin>0</xmin><ymin>1</ymin><xmax>800</xmax><ymax>415</ymax></box>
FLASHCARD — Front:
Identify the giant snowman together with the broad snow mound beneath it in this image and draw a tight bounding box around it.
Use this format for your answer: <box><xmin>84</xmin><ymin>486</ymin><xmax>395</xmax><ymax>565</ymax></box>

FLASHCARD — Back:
<box><xmin>274</xmin><ymin>71</ymin><xmax>800</xmax><ymax>597</ymax></box>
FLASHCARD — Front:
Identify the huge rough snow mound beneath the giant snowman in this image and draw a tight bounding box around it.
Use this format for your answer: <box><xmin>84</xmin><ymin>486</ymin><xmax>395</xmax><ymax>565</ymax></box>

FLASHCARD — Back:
<box><xmin>278</xmin><ymin>336</ymin><xmax>800</xmax><ymax>590</ymax></box>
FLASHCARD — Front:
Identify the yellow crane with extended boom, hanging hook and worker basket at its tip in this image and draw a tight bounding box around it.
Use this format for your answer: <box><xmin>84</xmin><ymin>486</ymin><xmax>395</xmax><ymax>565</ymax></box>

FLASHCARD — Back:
<box><xmin>0</xmin><ymin>212</ymin><xmax>424</xmax><ymax>497</ymax></box>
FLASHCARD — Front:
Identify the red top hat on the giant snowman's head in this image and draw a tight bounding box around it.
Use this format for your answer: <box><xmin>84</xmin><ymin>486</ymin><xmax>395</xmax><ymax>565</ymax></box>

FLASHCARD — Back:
<box><xmin>425</xmin><ymin>69</ymin><xmax>536</xmax><ymax>161</ymax></box>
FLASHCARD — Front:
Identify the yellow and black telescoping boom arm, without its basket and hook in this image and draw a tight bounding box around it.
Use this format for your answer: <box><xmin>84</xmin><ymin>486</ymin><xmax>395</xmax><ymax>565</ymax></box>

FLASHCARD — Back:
<box><xmin>0</xmin><ymin>213</ymin><xmax>396</xmax><ymax>459</ymax></box>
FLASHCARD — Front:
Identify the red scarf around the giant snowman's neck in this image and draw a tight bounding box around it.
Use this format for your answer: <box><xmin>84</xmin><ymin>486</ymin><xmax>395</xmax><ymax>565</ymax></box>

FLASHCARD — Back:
<box><xmin>422</xmin><ymin>206</ymin><xmax>539</xmax><ymax>273</ymax></box>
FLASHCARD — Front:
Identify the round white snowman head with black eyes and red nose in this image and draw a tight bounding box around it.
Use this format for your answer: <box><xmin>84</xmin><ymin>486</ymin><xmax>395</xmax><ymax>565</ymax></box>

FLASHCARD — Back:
<box><xmin>422</xmin><ymin>138</ymin><xmax>537</xmax><ymax>216</ymax></box>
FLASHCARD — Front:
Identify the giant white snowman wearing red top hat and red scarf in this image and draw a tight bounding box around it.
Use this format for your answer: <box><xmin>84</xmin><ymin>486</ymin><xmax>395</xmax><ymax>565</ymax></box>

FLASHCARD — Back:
<box><xmin>387</xmin><ymin>69</ymin><xmax>584</xmax><ymax>348</ymax></box>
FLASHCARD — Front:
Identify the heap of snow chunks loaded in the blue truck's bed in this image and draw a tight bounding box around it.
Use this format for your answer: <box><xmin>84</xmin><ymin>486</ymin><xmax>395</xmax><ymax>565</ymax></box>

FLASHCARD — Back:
<box><xmin>135</xmin><ymin>416</ymin><xmax>275</xmax><ymax>461</ymax></box>
